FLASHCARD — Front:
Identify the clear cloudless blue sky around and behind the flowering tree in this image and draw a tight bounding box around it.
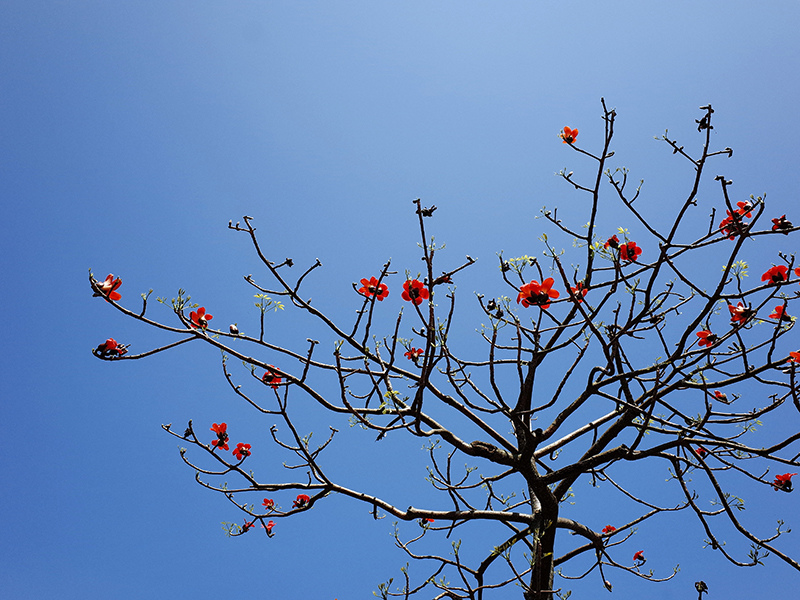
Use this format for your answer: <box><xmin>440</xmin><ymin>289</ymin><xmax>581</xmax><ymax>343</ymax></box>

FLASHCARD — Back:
<box><xmin>0</xmin><ymin>0</ymin><xmax>800</xmax><ymax>600</ymax></box>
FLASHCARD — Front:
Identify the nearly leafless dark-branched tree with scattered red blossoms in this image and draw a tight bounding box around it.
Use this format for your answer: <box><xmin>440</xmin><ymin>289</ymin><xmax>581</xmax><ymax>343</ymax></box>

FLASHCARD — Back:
<box><xmin>90</xmin><ymin>101</ymin><xmax>800</xmax><ymax>600</ymax></box>
